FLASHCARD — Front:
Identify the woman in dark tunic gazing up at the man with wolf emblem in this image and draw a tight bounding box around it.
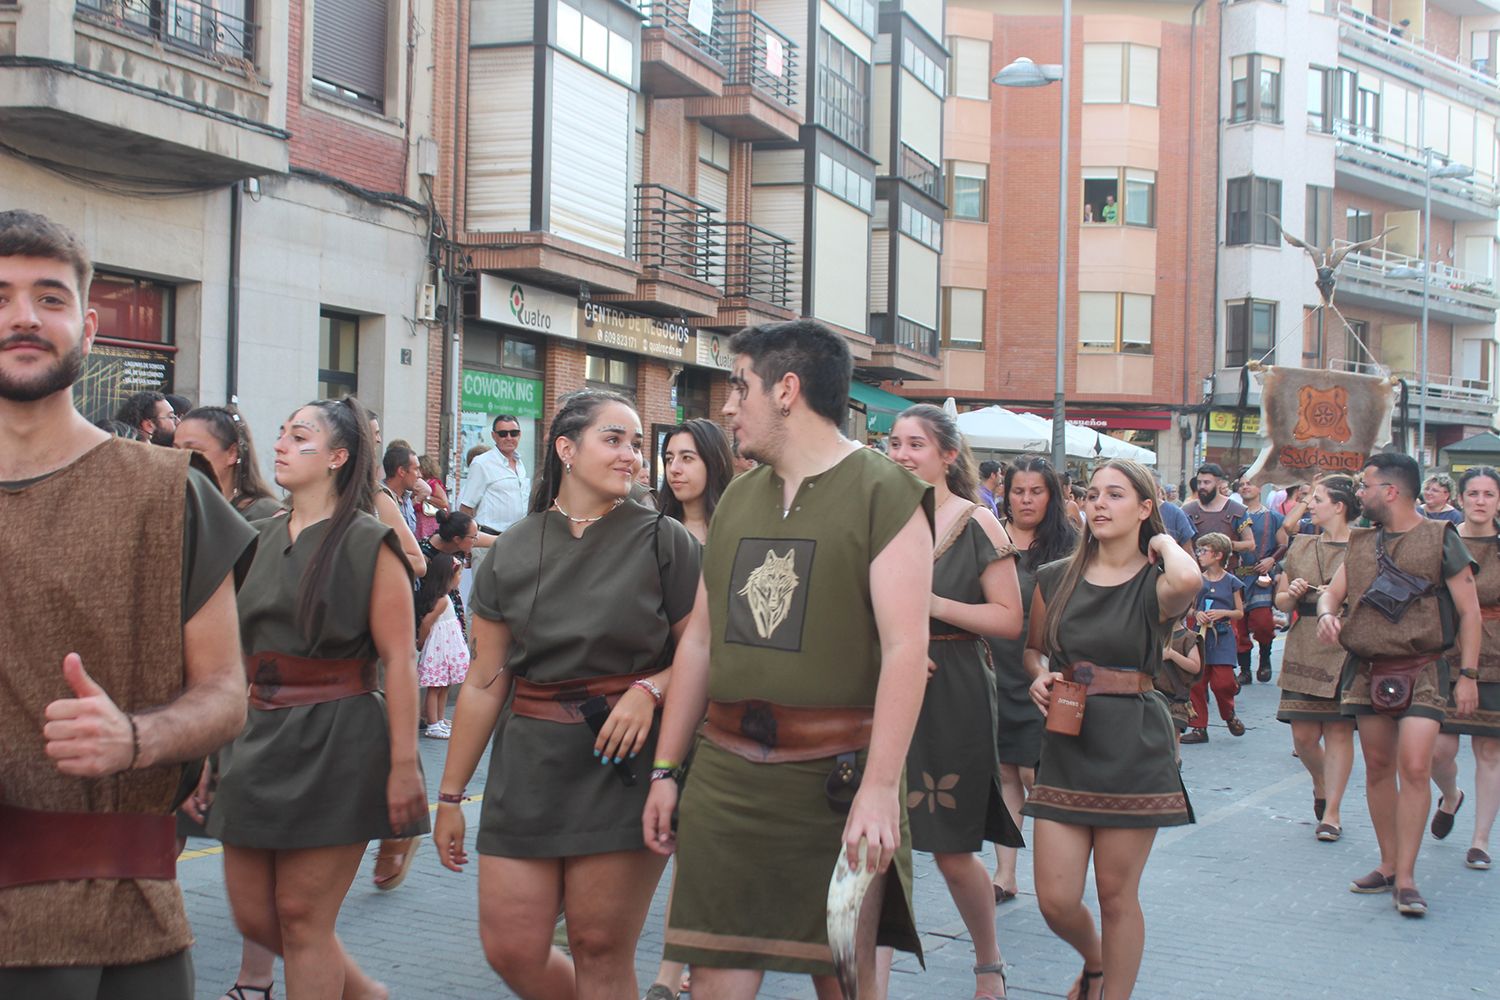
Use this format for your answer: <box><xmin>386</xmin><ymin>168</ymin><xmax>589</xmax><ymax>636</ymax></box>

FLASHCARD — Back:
<box><xmin>434</xmin><ymin>390</ymin><xmax>699</xmax><ymax>997</ymax></box>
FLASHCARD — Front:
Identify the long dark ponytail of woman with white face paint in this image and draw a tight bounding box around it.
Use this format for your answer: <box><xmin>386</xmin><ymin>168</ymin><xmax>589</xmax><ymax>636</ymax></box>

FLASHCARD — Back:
<box><xmin>297</xmin><ymin>396</ymin><xmax>375</xmax><ymax>640</ymax></box>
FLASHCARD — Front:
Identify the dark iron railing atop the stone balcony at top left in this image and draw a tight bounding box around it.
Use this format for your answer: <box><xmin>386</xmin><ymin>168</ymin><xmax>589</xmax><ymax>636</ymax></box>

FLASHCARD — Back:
<box><xmin>77</xmin><ymin>0</ymin><xmax>257</xmax><ymax>63</ymax></box>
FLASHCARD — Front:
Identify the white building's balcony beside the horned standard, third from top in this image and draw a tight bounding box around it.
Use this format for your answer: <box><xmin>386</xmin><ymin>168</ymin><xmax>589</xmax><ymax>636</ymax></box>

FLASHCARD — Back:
<box><xmin>1334</xmin><ymin>240</ymin><xmax>1500</xmax><ymax>324</ymax></box>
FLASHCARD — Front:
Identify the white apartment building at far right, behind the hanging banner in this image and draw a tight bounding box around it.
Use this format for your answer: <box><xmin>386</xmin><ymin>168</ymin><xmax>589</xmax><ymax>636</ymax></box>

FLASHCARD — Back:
<box><xmin>1203</xmin><ymin>0</ymin><xmax>1500</xmax><ymax>463</ymax></box>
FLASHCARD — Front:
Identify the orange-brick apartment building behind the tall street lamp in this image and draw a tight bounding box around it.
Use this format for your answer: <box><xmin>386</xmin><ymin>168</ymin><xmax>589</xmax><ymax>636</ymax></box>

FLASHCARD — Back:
<box><xmin>900</xmin><ymin>0</ymin><xmax>1220</xmax><ymax>481</ymax></box>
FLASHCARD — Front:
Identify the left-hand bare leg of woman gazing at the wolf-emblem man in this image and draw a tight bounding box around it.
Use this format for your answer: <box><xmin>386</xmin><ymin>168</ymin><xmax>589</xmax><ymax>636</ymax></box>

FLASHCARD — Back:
<box><xmin>479</xmin><ymin>855</ymin><xmax>576</xmax><ymax>1000</ymax></box>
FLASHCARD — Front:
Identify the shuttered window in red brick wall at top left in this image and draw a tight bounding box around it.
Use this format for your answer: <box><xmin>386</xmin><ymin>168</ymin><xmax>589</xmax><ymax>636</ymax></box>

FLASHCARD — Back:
<box><xmin>310</xmin><ymin>0</ymin><xmax>390</xmax><ymax>112</ymax></box>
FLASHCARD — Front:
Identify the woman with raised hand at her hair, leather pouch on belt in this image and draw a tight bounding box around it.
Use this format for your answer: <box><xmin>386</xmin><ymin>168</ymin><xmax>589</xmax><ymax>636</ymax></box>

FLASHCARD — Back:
<box><xmin>1025</xmin><ymin>460</ymin><xmax>1202</xmax><ymax>1000</ymax></box>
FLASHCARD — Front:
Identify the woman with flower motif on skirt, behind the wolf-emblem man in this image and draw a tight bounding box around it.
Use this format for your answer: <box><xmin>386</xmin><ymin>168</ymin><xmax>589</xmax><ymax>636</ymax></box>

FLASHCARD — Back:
<box><xmin>888</xmin><ymin>403</ymin><xmax>1022</xmax><ymax>1000</ymax></box>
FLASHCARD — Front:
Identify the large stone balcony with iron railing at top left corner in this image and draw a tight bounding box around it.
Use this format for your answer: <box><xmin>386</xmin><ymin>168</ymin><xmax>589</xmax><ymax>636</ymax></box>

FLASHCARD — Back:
<box><xmin>0</xmin><ymin>0</ymin><xmax>288</xmax><ymax>187</ymax></box>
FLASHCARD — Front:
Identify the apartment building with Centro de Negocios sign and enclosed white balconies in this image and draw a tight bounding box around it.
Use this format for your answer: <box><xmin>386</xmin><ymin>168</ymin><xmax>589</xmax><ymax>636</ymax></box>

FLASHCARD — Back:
<box><xmin>437</xmin><ymin>0</ymin><xmax>945</xmax><ymax>470</ymax></box>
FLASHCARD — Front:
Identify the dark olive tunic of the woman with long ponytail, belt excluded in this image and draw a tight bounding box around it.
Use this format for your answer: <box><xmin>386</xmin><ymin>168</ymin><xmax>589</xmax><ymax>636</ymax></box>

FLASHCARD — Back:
<box><xmin>209</xmin><ymin>513</ymin><xmax>431</xmax><ymax>850</ymax></box>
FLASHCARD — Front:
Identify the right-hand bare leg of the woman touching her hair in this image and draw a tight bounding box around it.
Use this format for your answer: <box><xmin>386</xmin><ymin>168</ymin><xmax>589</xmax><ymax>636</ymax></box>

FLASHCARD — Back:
<box><xmin>1094</xmin><ymin>828</ymin><xmax>1157</xmax><ymax>1000</ymax></box>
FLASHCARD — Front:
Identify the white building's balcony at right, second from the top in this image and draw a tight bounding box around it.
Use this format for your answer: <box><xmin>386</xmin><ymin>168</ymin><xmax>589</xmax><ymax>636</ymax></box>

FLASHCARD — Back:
<box><xmin>1334</xmin><ymin>118</ymin><xmax>1500</xmax><ymax>222</ymax></box>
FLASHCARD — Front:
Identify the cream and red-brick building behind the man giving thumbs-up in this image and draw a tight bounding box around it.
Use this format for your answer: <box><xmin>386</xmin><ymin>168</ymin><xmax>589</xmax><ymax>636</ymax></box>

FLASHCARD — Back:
<box><xmin>0</xmin><ymin>0</ymin><xmax>437</xmax><ymax>458</ymax></box>
